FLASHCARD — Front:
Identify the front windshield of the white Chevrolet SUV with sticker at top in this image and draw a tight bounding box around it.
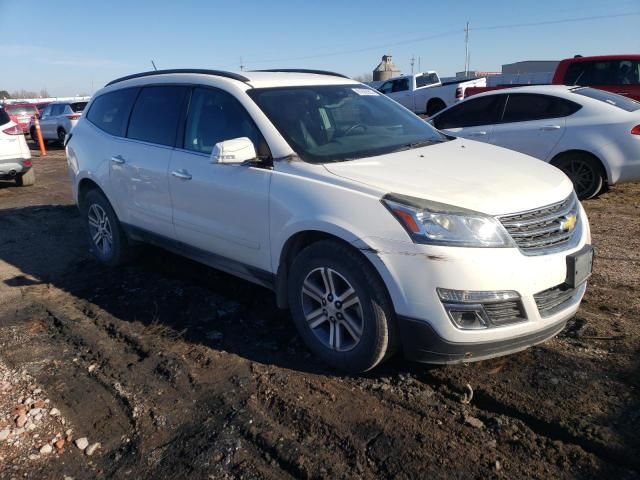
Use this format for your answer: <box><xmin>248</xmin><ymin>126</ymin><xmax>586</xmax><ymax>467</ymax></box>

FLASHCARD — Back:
<box><xmin>247</xmin><ymin>84</ymin><xmax>447</xmax><ymax>163</ymax></box>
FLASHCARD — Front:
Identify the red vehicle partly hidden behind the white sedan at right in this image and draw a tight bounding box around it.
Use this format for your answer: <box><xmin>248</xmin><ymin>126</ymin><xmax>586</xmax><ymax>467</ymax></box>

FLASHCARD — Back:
<box><xmin>465</xmin><ymin>55</ymin><xmax>640</xmax><ymax>101</ymax></box>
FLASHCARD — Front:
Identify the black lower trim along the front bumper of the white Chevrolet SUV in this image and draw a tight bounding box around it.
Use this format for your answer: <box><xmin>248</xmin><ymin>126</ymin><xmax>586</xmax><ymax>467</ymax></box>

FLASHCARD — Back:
<box><xmin>398</xmin><ymin>315</ymin><xmax>573</xmax><ymax>364</ymax></box>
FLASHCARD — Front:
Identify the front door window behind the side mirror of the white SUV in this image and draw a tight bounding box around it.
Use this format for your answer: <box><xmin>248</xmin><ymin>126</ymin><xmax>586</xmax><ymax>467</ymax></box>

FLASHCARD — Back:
<box><xmin>184</xmin><ymin>88</ymin><xmax>266</xmax><ymax>154</ymax></box>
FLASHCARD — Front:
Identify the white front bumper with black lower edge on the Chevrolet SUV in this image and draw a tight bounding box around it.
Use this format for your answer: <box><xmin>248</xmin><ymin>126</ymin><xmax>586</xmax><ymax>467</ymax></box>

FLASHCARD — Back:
<box><xmin>361</xmin><ymin>207</ymin><xmax>591</xmax><ymax>363</ymax></box>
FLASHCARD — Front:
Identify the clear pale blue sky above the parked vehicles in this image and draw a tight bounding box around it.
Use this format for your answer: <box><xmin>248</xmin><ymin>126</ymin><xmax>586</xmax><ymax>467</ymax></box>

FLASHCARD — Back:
<box><xmin>0</xmin><ymin>0</ymin><xmax>640</xmax><ymax>96</ymax></box>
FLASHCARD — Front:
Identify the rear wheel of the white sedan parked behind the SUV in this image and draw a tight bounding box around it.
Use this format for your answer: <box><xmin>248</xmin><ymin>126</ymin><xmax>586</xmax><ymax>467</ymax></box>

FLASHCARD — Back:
<box><xmin>553</xmin><ymin>152</ymin><xmax>606</xmax><ymax>200</ymax></box>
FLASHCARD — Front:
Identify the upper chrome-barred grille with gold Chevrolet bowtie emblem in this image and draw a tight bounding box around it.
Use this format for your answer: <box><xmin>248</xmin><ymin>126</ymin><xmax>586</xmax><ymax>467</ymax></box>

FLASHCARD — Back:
<box><xmin>498</xmin><ymin>194</ymin><xmax>580</xmax><ymax>255</ymax></box>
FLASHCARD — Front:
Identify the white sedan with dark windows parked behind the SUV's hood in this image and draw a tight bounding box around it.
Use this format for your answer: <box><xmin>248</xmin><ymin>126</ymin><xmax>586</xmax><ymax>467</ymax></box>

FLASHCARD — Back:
<box><xmin>429</xmin><ymin>85</ymin><xmax>640</xmax><ymax>199</ymax></box>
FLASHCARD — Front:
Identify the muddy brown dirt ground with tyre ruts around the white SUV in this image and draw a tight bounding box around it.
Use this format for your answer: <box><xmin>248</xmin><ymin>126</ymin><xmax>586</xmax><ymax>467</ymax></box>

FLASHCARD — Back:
<box><xmin>0</xmin><ymin>144</ymin><xmax>640</xmax><ymax>479</ymax></box>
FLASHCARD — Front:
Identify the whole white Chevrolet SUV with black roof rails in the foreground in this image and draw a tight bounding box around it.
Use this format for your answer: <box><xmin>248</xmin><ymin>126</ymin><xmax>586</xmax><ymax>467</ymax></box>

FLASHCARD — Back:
<box><xmin>67</xmin><ymin>70</ymin><xmax>592</xmax><ymax>372</ymax></box>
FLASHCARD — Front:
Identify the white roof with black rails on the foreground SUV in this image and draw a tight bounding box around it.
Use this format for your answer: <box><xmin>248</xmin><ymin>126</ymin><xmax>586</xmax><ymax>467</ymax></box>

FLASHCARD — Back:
<box><xmin>106</xmin><ymin>69</ymin><xmax>359</xmax><ymax>88</ymax></box>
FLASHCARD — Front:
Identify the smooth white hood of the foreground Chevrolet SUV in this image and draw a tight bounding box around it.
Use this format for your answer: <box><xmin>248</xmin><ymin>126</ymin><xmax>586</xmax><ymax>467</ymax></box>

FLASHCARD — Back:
<box><xmin>324</xmin><ymin>139</ymin><xmax>573</xmax><ymax>215</ymax></box>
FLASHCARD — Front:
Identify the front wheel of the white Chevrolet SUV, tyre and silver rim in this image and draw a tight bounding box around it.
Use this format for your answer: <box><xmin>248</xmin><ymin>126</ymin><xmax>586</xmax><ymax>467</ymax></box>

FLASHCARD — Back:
<box><xmin>288</xmin><ymin>240</ymin><xmax>397</xmax><ymax>373</ymax></box>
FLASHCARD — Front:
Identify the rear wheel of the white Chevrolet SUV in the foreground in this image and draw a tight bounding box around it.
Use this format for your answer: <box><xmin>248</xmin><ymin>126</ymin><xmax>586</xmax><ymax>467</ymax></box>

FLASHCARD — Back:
<box><xmin>81</xmin><ymin>189</ymin><xmax>133</xmax><ymax>267</ymax></box>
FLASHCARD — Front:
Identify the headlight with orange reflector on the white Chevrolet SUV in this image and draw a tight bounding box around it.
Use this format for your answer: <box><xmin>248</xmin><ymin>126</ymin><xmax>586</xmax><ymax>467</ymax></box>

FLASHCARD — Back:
<box><xmin>382</xmin><ymin>194</ymin><xmax>514</xmax><ymax>248</ymax></box>
